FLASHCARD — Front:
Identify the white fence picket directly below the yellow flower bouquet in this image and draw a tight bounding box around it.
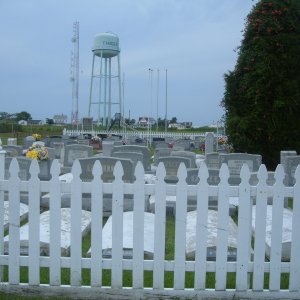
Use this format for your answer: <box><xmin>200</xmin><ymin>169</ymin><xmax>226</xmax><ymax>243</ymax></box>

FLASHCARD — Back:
<box><xmin>28</xmin><ymin>160</ymin><xmax>40</xmax><ymax>285</ymax></box>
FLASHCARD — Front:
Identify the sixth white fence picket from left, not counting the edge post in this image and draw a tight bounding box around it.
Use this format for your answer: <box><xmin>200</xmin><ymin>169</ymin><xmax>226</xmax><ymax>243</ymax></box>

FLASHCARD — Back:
<box><xmin>111</xmin><ymin>161</ymin><xmax>124</xmax><ymax>288</ymax></box>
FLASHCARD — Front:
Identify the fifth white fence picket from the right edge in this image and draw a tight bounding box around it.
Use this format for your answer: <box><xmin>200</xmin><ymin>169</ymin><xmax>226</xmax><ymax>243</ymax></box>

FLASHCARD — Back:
<box><xmin>216</xmin><ymin>164</ymin><xmax>229</xmax><ymax>291</ymax></box>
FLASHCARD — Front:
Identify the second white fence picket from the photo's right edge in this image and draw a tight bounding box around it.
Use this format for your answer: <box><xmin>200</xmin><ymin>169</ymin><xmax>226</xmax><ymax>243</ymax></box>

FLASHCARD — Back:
<box><xmin>270</xmin><ymin>165</ymin><xmax>285</xmax><ymax>291</ymax></box>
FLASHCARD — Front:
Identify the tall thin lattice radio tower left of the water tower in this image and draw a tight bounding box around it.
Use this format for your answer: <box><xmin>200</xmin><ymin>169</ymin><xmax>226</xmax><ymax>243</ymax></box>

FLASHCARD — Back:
<box><xmin>70</xmin><ymin>21</ymin><xmax>79</xmax><ymax>125</ymax></box>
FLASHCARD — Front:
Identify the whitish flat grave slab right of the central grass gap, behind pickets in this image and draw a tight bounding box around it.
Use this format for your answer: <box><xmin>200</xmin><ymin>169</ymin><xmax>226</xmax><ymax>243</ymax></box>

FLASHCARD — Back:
<box><xmin>186</xmin><ymin>210</ymin><xmax>237</xmax><ymax>261</ymax></box>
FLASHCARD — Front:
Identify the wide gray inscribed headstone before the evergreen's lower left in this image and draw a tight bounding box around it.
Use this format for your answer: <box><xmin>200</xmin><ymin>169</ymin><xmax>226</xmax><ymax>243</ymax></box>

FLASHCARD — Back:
<box><xmin>220</xmin><ymin>153</ymin><xmax>262</xmax><ymax>185</ymax></box>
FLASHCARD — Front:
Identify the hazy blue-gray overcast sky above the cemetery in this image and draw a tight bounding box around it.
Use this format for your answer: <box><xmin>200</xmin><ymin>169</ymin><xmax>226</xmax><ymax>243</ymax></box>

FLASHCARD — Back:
<box><xmin>0</xmin><ymin>0</ymin><xmax>257</xmax><ymax>125</ymax></box>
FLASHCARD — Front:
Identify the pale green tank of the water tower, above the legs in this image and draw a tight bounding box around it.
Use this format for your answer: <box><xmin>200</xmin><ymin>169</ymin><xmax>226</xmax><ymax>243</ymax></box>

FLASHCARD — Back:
<box><xmin>92</xmin><ymin>32</ymin><xmax>120</xmax><ymax>58</ymax></box>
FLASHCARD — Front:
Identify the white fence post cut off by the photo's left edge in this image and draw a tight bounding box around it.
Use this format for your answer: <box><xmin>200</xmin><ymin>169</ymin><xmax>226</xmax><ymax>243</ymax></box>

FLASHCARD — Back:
<box><xmin>0</xmin><ymin>139</ymin><xmax>6</xmax><ymax>282</ymax></box>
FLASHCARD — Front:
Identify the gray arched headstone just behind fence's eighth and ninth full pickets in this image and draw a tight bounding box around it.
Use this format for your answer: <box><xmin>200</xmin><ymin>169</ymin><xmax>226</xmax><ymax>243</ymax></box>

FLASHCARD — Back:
<box><xmin>158</xmin><ymin>156</ymin><xmax>191</xmax><ymax>183</ymax></box>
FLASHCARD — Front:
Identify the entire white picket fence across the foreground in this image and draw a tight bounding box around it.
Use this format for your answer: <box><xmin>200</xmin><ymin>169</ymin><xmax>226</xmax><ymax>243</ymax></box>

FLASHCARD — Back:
<box><xmin>0</xmin><ymin>153</ymin><xmax>300</xmax><ymax>299</ymax></box>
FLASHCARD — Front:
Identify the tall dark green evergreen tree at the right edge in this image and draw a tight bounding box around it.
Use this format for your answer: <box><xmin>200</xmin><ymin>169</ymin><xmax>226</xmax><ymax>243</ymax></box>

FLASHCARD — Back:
<box><xmin>222</xmin><ymin>0</ymin><xmax>300</xmax><ymax>169</ymax></box>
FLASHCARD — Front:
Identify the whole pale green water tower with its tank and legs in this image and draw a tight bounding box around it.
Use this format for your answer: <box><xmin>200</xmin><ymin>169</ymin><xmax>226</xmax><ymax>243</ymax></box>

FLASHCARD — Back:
<box><xmin>89</xmin><ymin>32</ymin><xmax>122</xmax><ymax>127</ymax></box>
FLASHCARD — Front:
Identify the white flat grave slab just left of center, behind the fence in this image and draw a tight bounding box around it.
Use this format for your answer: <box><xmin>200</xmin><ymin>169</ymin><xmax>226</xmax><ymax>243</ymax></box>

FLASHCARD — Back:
<box><xmin>87</xmin><ymin>211</ymin><xmax>155</xmax><ymax>259</ymax></box>
